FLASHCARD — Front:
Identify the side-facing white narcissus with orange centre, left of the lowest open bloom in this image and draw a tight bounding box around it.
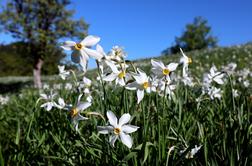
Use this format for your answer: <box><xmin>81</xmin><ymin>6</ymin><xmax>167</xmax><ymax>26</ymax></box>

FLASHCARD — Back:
<box><xmin>68</xmin><ymin>95</ymin><xmax>91</xmax><ymax>131</ymax></box>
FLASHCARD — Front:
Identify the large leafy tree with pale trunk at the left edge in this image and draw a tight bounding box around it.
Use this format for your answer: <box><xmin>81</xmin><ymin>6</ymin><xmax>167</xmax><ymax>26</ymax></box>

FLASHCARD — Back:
<box><xmin>0</xmin><ymin>0</ymin><xmax>88</xmax><ymax>88</ymax></box>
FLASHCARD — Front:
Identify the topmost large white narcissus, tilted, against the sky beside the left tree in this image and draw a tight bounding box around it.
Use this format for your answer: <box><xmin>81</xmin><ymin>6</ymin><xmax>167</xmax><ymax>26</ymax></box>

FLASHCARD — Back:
<box><xmin>61</xmin><ymin>35</ymin><xmax>102</xmax><ymax>71</ymax></box>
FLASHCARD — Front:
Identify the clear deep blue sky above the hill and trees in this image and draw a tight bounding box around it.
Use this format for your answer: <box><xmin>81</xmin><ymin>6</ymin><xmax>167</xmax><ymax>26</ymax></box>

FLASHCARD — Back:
<box><xmin>0</xmin><ymin>0</ymin><xmax>252</xmax><ymax>67</ymax></box>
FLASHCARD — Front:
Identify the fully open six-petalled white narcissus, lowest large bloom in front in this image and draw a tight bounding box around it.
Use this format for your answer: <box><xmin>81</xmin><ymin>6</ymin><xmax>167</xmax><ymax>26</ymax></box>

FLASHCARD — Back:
<box><xmin>97</xmin><ymin>111</ymin><xmax>139</xmax><ymax>148</ymax></box>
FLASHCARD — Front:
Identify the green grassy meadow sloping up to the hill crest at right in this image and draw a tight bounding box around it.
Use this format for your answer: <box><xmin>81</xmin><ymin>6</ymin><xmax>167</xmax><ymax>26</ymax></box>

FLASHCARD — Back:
<box><xmin>0</xmin><ymin>44</ymin><xmax>252</xmax><ymax>166</ymax></box>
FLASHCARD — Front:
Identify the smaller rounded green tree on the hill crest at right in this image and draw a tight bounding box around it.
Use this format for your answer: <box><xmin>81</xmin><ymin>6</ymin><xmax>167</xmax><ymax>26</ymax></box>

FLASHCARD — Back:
<box><xmin>163</xmin><ymin>17</ymin><xmax>217</xmax><ymax>54</ymax></box>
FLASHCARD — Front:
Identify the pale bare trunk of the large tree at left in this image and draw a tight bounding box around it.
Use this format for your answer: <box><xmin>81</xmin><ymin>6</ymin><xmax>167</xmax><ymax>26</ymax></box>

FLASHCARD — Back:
<box><xmin>33</xmin><ymin>58</ymin><xmax>44</xmax><ymax>89</ymax></box>
